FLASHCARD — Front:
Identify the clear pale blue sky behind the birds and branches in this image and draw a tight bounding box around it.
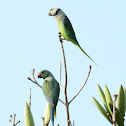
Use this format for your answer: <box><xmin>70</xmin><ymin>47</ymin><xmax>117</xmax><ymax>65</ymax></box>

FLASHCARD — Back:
<box><xmin>0</xmin><ymin>0</ymin><xmax>126</xmax><ymax>126</ymax></box>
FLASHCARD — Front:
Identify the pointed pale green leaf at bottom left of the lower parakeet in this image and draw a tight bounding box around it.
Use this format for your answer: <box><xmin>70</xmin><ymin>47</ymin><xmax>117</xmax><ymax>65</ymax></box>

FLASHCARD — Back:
<box><xmin>24</xmin><ymin>102</ymin><xmax>35</xmax><ymax>126</ymax></box>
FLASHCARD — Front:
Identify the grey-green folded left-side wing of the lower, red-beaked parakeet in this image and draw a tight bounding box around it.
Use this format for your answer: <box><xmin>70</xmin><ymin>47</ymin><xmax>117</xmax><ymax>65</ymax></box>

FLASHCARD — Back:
<box><xmin>43</xmin><ymin>80</ymin><xmax>54</xmax><ymax>107</ymax></box>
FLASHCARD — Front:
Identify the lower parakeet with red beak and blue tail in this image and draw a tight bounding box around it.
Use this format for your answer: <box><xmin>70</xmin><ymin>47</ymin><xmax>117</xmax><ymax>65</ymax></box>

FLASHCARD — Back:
<box><xmin>38</xmin><ymin>70</ymin><xmax>60</xmax><ymax>126</ymax></box>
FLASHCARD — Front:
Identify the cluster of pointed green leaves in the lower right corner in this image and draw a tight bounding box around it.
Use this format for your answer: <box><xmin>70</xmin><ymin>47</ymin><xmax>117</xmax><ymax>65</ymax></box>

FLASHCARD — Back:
<box><xmin>92</xmin><ymin>85</ymin><xmax>126</xmax><ymax>126</ymax></box>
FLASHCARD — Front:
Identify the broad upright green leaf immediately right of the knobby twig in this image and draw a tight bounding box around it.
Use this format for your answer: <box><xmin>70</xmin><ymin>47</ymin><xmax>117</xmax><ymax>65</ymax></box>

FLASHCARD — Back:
<box><xmin>117</xmin><ymin>85</ymin><xmax>125</xmax><ymax>117</ymax></box>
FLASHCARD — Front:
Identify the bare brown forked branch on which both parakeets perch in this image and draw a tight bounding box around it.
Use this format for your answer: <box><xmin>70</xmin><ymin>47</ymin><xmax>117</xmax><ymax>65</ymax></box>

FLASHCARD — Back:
<box><xmin>27</xmin><ymin>32</ymin><xmax>91</xmax><ymax>126</ymax></box>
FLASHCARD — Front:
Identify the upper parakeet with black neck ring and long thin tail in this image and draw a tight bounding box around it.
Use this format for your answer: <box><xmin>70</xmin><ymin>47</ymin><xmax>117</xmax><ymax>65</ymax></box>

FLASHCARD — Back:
<box><xmin>49</xmin><ymin>8</ymin><xmax>97</xmax><ymax>65</ymax></box>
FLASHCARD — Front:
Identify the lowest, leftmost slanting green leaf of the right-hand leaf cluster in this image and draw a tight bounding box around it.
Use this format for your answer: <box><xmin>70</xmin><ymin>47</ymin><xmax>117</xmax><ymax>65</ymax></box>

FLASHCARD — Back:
<box><xmin>92</xmin><ymin>97</ymin><xmax>112</xmax><ymax>124</ymax></box>
